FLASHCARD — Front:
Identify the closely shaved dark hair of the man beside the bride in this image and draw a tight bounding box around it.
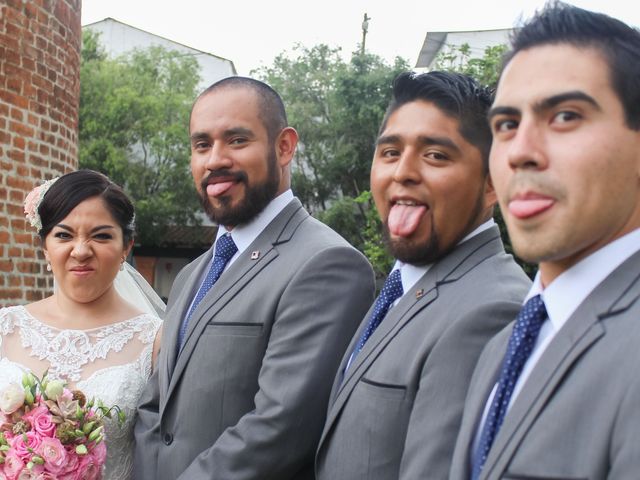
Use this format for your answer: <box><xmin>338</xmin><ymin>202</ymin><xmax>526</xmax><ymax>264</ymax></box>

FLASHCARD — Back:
<box><xmin>191</xmin><ymin>76</ymin><xmax>288</xmax><ymax>143</ymax></box>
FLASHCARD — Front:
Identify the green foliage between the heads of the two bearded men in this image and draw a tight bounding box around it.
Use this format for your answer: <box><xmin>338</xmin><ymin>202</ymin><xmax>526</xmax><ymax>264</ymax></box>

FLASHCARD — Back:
<box><xmin>252</xmin><ymin>45</ymin><xmax>409</xmax><ymax>274</ymax></box>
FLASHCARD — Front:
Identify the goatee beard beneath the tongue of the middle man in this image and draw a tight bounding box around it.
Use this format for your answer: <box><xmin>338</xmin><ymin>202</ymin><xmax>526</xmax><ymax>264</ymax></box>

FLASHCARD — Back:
<box><xmin>382</xmin><ymin>193</ymin><xmax>483</xmax><ymax>265</ymax></box>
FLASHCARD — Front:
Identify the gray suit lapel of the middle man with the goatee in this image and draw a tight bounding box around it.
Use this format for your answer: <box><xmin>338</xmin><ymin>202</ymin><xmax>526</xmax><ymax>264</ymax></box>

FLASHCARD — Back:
<box><xmin>320</xmin><ymin>227</ymin><xmax>504</xmax><ymax>444</ymax></box>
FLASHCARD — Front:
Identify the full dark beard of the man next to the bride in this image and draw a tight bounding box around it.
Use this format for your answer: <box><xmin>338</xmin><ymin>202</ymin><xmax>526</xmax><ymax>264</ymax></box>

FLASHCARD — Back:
<box><xmin>199</xmin><ymin>150</ymin><xmax>280</xmax><ymax>227</ymax></box>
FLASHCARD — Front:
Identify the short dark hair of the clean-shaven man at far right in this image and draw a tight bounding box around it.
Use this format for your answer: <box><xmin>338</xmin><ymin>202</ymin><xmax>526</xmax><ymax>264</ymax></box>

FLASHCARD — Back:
<box><xmin>503</xmin><ymin>1</ymin><xmax>640</xmax><ymax>130</ymax></box>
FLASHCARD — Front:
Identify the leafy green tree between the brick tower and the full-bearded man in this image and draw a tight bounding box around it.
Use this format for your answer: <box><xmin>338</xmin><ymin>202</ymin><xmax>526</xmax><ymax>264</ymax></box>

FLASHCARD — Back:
<box><xmin>79</xmin><ymin>31</ymin><xmax>200</xmax><ymax>245</ymax></box>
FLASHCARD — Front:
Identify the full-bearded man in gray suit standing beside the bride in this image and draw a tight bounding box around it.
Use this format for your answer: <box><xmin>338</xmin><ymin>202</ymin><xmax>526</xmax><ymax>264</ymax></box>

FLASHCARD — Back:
<box><xmin>135</xmin><ymin>77</ymin><xmax>374</xmax><ymax>480</ymax></box>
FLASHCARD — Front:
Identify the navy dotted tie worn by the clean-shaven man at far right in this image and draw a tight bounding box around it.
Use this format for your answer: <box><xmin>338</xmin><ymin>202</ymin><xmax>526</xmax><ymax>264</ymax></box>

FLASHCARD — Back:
<box><xmin>471</xmin><ymin>295</ymin><xmax>547</xmax><ymax>480</ymax></box>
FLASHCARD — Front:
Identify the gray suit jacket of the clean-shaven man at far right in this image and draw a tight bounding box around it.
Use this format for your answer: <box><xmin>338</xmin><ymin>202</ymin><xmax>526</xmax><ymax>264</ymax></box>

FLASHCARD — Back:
<box><xmin>450</xmin><ymin>248</ymin><xmax>640</xmax><ymax>480</ymax></box>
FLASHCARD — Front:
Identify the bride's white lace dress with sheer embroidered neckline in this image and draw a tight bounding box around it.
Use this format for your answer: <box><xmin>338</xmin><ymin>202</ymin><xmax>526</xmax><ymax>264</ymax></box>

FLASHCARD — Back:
<box><xmin>0</xmin><ymin>306</ymin><xmax>161</xmax><ymax>480</ymax></box>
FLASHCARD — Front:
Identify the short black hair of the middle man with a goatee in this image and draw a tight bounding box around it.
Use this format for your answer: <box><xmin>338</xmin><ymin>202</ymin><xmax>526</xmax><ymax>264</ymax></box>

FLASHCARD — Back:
<box><xmin>378</xmin><ymin>71</ymin><xmax>493</xmax><ymax>172</ymax></box>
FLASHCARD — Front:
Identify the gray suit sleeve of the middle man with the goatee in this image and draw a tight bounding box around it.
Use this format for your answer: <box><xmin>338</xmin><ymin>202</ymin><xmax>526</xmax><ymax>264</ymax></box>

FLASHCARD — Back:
<box><xmin>400</xmin><ymin>301</ymin><xmax>520</xmax><ymax>480</ymax></box>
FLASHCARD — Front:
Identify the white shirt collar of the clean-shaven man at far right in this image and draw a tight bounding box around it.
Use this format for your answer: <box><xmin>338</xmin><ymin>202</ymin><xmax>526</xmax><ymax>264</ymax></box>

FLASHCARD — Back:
<box><xmin>525</xmin><ymin>228</ymin><xmax>640</xmax><ymax>331</ymax></box>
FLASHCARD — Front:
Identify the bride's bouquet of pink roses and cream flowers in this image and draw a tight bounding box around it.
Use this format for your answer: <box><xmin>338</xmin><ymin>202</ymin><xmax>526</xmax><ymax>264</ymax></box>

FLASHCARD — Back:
<box><xmin>0</xmin><ymin>373</ymin><xmax>125</xmax><ymax>480</ymax></box>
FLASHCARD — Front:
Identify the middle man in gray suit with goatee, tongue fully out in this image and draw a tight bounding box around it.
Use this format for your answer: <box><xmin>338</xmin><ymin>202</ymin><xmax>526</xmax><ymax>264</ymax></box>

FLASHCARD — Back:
<box><xmin>316</xmin><ymin>72</ymin><xmax>530</xmax><ymax>480</ymax></box>
